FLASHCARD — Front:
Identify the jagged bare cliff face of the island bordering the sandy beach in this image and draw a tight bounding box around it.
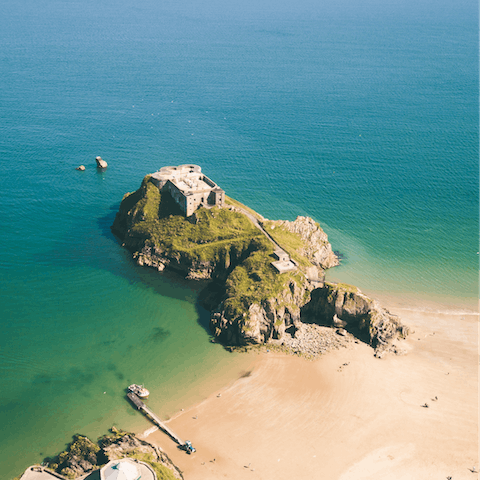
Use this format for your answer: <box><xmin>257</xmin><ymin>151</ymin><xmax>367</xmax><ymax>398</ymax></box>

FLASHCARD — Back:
<box><xmin>211</xmin><ymin>282</ymin><xmax>408</xmax><ymax>350</ymax></box>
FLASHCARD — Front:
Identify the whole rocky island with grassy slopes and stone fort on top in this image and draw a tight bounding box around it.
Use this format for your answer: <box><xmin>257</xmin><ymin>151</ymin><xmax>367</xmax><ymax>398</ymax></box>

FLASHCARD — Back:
<box><xmin>112</xmin><ymin>165</ymin><xmax>408</xmax><ymax>354</ymax></box>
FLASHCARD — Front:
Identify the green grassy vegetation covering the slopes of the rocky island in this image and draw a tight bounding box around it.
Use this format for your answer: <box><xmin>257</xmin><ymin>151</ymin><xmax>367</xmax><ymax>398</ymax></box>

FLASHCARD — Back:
<box><xmin>112</xmin><ymin>175</ymin><xmax>318</xmax><ymax>343</ymax></box>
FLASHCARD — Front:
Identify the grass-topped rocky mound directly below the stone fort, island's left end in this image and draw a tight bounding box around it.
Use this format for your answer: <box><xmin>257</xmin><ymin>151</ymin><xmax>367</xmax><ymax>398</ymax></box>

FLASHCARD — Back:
<box><xmin>112</xmin><ymin>176</ymin><xmax>266</xmax><ymax>280</ymax></box>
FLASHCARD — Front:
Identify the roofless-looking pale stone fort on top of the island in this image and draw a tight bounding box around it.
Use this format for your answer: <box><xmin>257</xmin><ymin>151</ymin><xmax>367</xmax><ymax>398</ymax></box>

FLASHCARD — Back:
<box><xmin>151</xmin><ymin>165</ymin><xmax>225</xmax><ymax>217</ymax></box>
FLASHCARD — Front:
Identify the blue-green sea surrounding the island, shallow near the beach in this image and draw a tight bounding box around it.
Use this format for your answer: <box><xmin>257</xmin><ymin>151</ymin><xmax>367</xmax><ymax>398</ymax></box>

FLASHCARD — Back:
<box><xmin>0</xmin><ymin>0</ymin><xmax>479</xmax><ymax>480</ymax></box>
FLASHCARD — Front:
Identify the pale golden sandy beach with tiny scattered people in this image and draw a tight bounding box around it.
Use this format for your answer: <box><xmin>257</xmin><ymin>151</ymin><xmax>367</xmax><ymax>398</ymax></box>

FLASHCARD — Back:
<box><xmin>142</xmin><ymin>308</ymin><xmax>480</xmax><ymax>480</ymax></box>
